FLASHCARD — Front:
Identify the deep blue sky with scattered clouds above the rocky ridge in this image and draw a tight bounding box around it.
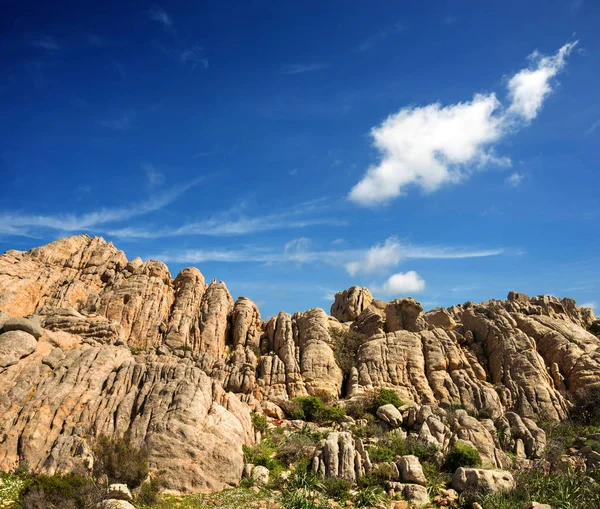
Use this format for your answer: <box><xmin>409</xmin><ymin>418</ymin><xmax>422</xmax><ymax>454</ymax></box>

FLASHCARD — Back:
<box><xmin>0</xmin><ymin>0</ymin><xmax>600</xmax><ymax>317</ymax></box>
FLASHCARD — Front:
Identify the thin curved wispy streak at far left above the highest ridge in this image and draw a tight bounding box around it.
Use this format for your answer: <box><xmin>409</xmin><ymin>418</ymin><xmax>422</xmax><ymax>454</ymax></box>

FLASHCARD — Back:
<box><xmin>0</xmin><ymin>179</ymin><xmax>202</xmax><ymax>236</ymax></box>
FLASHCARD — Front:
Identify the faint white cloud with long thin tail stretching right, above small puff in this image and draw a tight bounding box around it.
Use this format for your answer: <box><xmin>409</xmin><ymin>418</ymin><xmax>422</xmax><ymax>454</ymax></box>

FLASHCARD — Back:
<box><xmin>344</xmin><ymin>237</ymin><xmax>504</xmax><ymax>276</ymax></box>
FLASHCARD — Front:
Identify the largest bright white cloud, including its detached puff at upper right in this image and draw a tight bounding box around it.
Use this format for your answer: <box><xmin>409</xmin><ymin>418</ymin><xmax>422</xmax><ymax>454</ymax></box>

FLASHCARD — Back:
<box><xmin>349</xmin><ymin>43</ymin><xmax>576</xmax><ymax>206</ymax></box>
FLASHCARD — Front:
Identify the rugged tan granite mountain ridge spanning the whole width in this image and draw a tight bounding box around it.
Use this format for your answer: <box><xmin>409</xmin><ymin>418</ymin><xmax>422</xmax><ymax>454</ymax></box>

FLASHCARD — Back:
<box><xmin>0</xmin><ymin>235</ymin><xmax>600</xmax><ymax>500</ymax></box>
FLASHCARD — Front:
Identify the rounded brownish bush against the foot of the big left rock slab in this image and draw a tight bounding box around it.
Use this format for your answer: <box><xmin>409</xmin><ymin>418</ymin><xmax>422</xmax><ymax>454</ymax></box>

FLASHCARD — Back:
<box><xmin>94</xmin><ymin>435</ymin><xmax>148</xmax><ymax>489</ymax></box>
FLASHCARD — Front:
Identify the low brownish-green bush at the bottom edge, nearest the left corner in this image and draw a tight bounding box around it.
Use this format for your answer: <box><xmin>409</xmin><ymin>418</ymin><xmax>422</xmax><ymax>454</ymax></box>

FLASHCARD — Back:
<box><xmin>19</xmin><ymin>474</ymin><xmax>104</xmax><ymax>509</ymax></box>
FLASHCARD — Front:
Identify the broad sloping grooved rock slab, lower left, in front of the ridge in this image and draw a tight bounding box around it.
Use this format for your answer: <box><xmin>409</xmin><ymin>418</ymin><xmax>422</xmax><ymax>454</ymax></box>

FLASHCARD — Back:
<box><xmin>0</xmin><ymin>308</ymin><xmax>253</xmax><ymax>490</ymax></box>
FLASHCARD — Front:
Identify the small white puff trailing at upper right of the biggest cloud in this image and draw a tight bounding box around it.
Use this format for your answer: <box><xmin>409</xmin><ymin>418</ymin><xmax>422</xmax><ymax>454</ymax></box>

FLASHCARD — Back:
<box><xmin>508</xmin><ymin>41</ymin><xmax>577</xmax><ymax>122</ymax></box>
